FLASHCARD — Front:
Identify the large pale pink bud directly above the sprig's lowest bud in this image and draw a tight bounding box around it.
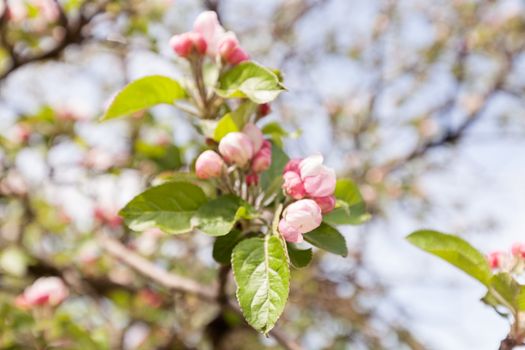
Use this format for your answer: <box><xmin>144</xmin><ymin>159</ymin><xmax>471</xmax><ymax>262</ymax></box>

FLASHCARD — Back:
<box><xmin>299</xmin><ymin>155</ymin><xmax>336</xmax><ymax>197</ymax></box>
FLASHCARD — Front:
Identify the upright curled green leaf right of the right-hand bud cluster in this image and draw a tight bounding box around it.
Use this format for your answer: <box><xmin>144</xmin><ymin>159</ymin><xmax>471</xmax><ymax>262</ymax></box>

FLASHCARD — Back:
<box><xmin>323</xmin><ymin>179</ymin><xmax>371</xmax><ymax>225</ymax></box>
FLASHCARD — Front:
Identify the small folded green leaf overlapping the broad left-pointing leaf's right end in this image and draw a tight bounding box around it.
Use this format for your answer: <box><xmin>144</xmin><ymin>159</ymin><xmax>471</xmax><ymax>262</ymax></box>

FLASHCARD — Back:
<box><xmin>192</xmin><ymin>195</ymin><xmax>244</xmax><ymax>236</ymax></box>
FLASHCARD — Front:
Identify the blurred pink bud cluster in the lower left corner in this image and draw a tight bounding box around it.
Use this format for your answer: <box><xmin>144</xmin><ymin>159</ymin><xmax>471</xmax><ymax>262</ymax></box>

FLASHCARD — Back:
<box><xmin>15</xmin><ymin>277</ymin><xmax>69</xmax><ymax>309</ymax></box>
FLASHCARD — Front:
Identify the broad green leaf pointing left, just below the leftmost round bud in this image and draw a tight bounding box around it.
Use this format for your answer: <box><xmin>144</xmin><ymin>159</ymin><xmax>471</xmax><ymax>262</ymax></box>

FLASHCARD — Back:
<box><xmin>120</xmin><ymin>182</ymin><xmax>207</xmax><ymax>234</ymax></box>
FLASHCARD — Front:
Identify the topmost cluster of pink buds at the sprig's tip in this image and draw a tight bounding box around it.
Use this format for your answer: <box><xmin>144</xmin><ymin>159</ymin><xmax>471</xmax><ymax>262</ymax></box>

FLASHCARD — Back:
<box><xmin>170</xmin><ymin>11</ymin><xmax>249</xmax><ymax>65</ymax></box>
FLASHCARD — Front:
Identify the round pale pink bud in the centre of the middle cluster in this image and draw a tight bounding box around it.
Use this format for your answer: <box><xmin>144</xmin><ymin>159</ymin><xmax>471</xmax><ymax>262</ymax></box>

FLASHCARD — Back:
<box><xmin>219</xmin><ymin>132</ymin><xmax>254</xmax><ymax>167</ymax></box>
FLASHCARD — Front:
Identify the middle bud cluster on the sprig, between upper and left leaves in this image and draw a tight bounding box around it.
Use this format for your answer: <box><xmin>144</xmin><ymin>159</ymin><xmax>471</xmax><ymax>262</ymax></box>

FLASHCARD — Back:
<box><xmin>195</xmin><ymin>123</ymin><xmax>272</xmax><ymax>186</ymax></box>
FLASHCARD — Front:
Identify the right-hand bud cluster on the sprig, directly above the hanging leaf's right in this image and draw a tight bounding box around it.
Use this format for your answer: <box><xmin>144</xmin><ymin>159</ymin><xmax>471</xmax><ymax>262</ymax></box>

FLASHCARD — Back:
<box><xmin>279</xmin><ymin>155</ymin><xmax>336</xmax><ymax>243</ymax></box>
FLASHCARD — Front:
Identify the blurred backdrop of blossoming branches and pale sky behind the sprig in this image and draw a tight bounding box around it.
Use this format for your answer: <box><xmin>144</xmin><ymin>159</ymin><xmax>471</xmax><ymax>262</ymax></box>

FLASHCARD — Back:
<box><xmin>0</xmin><ymin>0</ymin><xmax>525</xmax><ymax>350</ymax></box>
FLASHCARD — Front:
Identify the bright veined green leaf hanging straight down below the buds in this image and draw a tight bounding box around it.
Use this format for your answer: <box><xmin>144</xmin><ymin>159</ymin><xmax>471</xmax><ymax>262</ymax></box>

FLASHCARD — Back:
<box><xmin>232</xmin><ymin>235</ymin><xmax>290</xmax><ymax>333</ymax></box>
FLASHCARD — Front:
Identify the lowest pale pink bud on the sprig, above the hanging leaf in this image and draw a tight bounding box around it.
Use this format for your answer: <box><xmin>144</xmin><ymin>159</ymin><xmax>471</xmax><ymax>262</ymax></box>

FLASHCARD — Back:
<box><xmin>279</xmin><ymin>199</ymin><xmax>323</xmax><ymax>243</ymax></box>
